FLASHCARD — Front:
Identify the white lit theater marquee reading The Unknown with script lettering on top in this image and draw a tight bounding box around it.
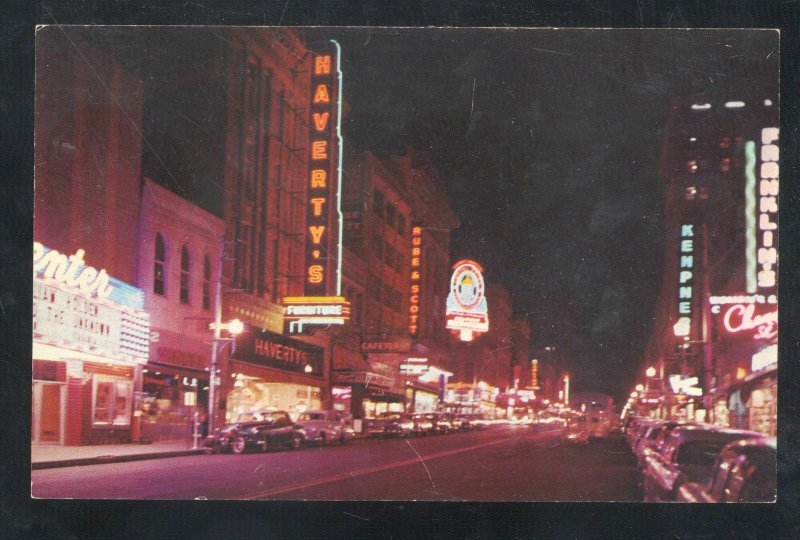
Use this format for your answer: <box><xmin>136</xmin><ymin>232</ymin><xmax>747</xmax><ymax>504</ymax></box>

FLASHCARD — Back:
<box><xmin>32</xmin><ymin>242</ymin><xmax>150</xmax><ymax>364</ymax></box>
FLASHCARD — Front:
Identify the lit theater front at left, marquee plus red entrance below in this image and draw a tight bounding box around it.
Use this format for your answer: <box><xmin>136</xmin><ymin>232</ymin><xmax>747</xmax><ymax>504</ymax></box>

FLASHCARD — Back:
<box><xmin>31</xmin><ymin>242</ymin><xmax>150</xmax><ymax>445</ymax></box>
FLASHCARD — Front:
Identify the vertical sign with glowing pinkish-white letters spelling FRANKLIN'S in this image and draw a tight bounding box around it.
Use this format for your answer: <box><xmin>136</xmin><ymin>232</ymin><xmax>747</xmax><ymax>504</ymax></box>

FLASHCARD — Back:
<box><xmin>758</xmin><ymin>127</ymin><xmax>780</xmax><ymax>291</ymax></box>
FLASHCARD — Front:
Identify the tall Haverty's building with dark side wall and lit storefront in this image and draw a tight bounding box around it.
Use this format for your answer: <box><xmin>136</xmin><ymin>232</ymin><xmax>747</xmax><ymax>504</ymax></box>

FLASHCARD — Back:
<box><xmin>139</xmin><ymin>28</ymin><xmax>338</xmax><ymax>423</ymax></box>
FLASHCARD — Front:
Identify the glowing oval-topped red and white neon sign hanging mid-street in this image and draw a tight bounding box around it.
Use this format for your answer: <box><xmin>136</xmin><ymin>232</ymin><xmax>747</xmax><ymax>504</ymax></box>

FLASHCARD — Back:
<box><xmin>446</xmin><ymin>259</ymin><xmax>489</xmax><ymax>341</ymax></box>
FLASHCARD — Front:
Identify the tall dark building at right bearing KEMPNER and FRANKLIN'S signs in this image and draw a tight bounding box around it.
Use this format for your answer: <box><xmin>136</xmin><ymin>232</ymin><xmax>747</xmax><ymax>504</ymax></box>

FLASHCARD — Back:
<box><xmin>643</xmin><ymin>96</ymin><xmax>779</xmax><ymax>434</ymax></box>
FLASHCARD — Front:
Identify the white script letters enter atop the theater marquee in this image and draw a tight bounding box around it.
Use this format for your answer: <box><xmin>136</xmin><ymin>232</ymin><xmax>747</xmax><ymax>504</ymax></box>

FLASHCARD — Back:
<box><xmin>33</xmin><ymin>242</ymin><xmax>114</xmax><ymax>298</ymax></box>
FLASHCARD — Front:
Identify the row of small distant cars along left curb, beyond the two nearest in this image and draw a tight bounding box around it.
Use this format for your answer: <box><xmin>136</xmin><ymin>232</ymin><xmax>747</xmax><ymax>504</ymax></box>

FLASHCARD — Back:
<box><xmin>366</xmin><ymin>412</ymin><xmax>488</xmax><ymax>437</ymax></box>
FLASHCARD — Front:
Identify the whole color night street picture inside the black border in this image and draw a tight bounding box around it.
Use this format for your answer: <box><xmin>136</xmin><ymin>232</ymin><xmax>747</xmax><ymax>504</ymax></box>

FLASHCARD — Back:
<box><xmin>31</xmin><ymin>26</ymin><xmax>776</xmax><ymax>503</ymax></box>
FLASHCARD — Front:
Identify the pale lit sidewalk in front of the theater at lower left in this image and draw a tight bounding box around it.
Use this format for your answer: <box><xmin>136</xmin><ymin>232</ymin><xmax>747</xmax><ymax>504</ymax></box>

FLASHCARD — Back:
<box><xmin>31</xmin><ymin>440</ymin><xmax>203</xmax><ymax>469</ymax></box>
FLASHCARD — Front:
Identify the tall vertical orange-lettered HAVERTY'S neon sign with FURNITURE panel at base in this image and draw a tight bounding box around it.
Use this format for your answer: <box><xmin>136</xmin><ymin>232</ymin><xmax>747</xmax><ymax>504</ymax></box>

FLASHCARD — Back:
<box><xmin>283</xmin><ymin>40</ymin><xmax>350</xmax><ymax>334</ymax></box>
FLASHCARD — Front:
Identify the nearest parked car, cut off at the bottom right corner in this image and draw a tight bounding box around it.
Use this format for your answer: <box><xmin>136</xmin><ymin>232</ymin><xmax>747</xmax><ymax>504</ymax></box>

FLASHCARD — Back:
<box><xmin>678</xmin><ymin>437</ymin><xmax>777</xmax><ymax>503</ymax></box>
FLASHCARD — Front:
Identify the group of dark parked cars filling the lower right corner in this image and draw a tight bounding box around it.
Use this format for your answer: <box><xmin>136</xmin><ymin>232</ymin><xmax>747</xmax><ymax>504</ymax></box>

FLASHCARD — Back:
<box><xmin>624</xmin><ymin>418</ymin><xmax>777</xmax><ymax>502</ymax></box>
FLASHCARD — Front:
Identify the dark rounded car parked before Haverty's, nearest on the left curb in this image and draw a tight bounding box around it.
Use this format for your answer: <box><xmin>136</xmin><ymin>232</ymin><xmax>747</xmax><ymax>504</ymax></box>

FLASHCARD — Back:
<box><xmin>204</xmin><ymin>410</ymin><xmax>305</xmax><ymax>454</ymax></box>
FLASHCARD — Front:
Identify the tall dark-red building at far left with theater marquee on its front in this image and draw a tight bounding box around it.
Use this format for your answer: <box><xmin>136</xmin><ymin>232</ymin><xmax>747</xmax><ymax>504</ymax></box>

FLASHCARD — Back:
<box><xmin>31</xmin><ymin>26</ymin><xmax>149</xmax><ymax>445</ymax></box>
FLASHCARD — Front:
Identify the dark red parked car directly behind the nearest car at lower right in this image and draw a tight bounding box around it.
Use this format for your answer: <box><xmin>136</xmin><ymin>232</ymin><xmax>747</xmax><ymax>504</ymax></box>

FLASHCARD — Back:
<box><xmin>643</xmin><ymin>425</ymin><xmax>760</xmax><ymax>501</ymax></box>
